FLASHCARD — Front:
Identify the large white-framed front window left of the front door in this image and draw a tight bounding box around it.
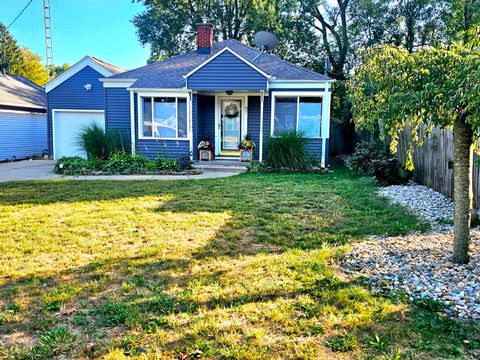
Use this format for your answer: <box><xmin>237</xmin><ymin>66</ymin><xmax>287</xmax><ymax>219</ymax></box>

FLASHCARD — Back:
<box><xmin>141</xmin><ymin>97</ymin><xmax>188</xmax><ymax>139</ymax></box>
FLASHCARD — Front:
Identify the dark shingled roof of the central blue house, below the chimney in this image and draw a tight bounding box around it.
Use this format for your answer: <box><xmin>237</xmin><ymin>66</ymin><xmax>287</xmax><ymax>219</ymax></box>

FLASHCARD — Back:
<box><xmin>110</xmin><ymin>39</ymin><xmax>330</xmax><ymax>89</ymax></box>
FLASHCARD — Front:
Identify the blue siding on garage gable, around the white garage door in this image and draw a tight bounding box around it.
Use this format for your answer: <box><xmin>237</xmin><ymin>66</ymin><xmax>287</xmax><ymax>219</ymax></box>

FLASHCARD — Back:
<box><xmin>47</xmin><ymin>66</ymin><xmax>105</xmax><ymax>156</ymax></box>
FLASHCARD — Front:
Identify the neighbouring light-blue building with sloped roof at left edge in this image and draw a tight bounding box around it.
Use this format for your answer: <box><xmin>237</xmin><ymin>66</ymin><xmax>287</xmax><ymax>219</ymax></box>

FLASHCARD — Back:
<box><xmin>0</xmin><ymin>71</ymin><xmax>48</xmax><ymax>161</ymax></box>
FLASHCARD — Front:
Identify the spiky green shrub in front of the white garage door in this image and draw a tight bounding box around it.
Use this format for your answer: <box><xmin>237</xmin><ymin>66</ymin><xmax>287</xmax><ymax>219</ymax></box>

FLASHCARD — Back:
<box><xmin>79</xmin><ymin>123</ymin><xmax>123</xmax><ymax>160</ymax></box>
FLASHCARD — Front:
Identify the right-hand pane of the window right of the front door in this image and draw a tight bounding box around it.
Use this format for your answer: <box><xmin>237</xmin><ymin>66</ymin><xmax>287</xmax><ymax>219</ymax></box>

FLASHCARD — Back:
<box><xmin>298</xmin><ymin>97</ymin><xmax>322</xmax><ymax>138</ymax></box>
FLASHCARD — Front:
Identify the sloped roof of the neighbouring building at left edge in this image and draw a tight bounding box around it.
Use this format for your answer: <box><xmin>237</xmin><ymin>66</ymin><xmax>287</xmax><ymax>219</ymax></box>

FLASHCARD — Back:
<box><xmin>0</xmin><ymin>73</ymin><xmax>47</xmax><ymax>109</ymax></box>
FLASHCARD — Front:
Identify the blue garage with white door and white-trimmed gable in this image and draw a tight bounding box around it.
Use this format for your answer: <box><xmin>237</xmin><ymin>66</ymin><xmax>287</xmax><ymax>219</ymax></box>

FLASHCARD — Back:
<box><xmin>45</xmin><ymin>56</ymin><xmax>125</xmax><ymax>160</ymax></box>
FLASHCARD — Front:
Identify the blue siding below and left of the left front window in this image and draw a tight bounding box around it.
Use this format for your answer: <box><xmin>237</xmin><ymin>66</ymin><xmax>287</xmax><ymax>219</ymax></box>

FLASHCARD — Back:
<box><xmin>134</xmin><ymin>94</ymin><xmax>191</xmax><ymax>160</ymax></box>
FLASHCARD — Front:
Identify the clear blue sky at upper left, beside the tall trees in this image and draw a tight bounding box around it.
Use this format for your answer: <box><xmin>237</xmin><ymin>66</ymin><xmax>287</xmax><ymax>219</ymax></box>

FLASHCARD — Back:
<box><xmin>0</xmin><ymin>0</ymin><xmax>150</xmax><ymax>69</ymax></box>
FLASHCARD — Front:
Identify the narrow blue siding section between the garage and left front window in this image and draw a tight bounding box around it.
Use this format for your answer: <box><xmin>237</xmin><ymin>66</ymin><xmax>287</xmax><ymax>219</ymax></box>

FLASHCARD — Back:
<box><xmin>105</xmin><ymin>88</ymin><xmax>131</xmax><ymax>151</ymax></box>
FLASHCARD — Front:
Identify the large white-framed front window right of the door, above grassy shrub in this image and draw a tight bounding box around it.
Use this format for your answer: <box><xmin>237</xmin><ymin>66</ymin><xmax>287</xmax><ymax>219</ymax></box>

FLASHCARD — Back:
<box><xmin>272</xmin><ymin>95</ymin><xmax>322</xmax><ymax>138</ymax></box>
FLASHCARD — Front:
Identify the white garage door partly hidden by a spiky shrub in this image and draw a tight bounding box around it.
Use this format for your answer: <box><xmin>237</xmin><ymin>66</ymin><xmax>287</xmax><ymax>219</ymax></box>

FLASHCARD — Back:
<box><xmin>53</xmin><ymin>110</ymin><xmax>105</xmax><ymax>159</ymax></box>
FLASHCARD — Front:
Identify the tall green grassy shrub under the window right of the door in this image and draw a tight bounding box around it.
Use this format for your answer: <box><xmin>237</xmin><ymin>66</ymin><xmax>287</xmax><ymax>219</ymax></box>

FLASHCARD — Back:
<box><xmin>266</xmin><ymin>131</ymin><xmax>311</xmax><ymax>171</ymax></box>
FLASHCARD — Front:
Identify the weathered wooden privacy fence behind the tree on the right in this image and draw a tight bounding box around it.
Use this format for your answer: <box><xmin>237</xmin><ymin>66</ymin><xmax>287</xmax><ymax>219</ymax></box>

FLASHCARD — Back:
<box><xmin>398</xmin><ymin>128</ymin><xmax>480</xmax><ymax>209</ymax></box>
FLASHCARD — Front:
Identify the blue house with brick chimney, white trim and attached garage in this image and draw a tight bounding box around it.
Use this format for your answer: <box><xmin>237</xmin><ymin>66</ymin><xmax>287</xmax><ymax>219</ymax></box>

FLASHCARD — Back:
<box><xmin>46</xmin><ymin>24</ymin><xmax>332</xmax><ymax>166</ymax></box>
